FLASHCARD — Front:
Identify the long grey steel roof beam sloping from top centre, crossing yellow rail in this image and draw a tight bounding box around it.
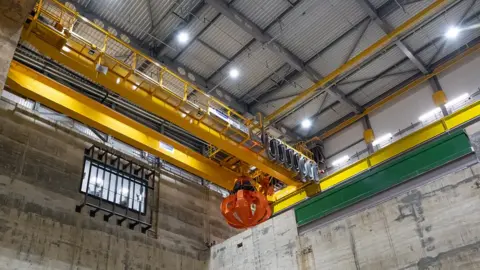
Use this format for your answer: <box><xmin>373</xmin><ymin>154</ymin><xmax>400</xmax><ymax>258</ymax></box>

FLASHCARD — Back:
<box><xmin>205</xmin><ymin>0</ymin><xmax>363</xmax><ymax>113</ymax></box>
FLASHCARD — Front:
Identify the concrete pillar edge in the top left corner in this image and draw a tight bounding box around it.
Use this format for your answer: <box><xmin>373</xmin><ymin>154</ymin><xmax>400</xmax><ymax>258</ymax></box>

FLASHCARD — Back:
<box><xmin>0</xmin><ymin>0</ymin><xmax>36</xmax><ymax>95</ymax></box>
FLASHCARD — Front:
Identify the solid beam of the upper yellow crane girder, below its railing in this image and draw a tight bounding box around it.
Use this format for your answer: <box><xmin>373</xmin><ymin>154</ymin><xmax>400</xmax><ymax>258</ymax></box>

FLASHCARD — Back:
<box><xmin>22</xmin><ymin>21</ymin><xmax>302</xmax><ymax>186</ymax></box>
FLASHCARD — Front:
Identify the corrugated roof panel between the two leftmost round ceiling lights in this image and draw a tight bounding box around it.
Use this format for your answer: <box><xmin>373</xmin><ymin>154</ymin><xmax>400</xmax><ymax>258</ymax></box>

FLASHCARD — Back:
<box><xmin>178</xmin><ymin>41</ymin><xmax>226</xmax><ymax>78</ymax></box>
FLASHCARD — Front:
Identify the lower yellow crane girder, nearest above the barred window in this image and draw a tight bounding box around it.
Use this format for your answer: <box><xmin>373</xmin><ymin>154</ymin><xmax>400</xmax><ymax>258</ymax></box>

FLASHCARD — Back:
<box><xmin>7</xmin><ymin>61</ymin><xmax>237</xmax><ymax>189</ymax></box>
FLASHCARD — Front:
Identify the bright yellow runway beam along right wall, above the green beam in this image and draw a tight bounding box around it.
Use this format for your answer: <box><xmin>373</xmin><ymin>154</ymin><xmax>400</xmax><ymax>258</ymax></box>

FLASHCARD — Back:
<box><xmin>273</xmin><ymin>101</ymin><xmax>480</xmax><ymax>212</ymax></box>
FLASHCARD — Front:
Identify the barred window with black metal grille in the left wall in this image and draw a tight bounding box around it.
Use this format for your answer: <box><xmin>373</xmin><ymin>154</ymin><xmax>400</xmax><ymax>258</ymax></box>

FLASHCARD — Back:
<box><xmin>75</xmin><ymin>146</ymin><xmax>158</xmax><ymax>233</ymax></box>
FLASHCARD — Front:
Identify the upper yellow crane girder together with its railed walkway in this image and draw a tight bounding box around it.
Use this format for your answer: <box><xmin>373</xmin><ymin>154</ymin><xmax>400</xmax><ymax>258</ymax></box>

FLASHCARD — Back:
<box><xmin>22</xmin><ymin>0</ymin><xmax>301</xmax><ymax>186</ymax></box>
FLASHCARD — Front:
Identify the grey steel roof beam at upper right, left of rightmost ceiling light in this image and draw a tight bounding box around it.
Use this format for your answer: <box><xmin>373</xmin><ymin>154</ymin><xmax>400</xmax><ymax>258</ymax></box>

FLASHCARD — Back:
<box><xmin>356</xmin><ymin>0</ymin><xmax>429</xmax><ymax>74</ymax></box>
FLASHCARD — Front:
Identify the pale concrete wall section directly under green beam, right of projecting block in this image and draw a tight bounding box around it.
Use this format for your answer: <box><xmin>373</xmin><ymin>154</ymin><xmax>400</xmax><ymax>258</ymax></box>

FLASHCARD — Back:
<box><xmin>300</xmin><ymin>159</ymin><xmax>480</xmax><ymax>269</ymax></box>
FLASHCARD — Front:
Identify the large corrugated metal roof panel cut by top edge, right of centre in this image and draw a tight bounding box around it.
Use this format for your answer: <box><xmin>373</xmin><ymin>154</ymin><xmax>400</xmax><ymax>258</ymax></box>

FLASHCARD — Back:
<box><xmin>268</xmin><ymin>0</ymin><xmax>366</xmax><ymax>61</ymax></box>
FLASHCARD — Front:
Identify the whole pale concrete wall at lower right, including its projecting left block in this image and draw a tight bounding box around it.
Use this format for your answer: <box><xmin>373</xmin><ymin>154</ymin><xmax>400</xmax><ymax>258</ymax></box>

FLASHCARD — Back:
<box><xmin>210</xmin><ymin>134</ymin><xmax>480</xmax><ymax>270</ymax></box>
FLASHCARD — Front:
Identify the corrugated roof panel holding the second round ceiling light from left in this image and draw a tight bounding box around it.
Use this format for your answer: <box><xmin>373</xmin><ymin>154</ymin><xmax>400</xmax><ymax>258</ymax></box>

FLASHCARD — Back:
<box><xmin>212</xmin><ymin>42</ymin><xmax>284</xmax><ymax>98</ymax></box>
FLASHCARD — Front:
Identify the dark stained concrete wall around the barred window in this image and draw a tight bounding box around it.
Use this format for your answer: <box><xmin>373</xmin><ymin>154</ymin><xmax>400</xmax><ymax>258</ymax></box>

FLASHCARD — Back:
<box><xmin>0</xmin><ymin>103</ymin><xmax>236</xmax><ymax>269</ymax></box>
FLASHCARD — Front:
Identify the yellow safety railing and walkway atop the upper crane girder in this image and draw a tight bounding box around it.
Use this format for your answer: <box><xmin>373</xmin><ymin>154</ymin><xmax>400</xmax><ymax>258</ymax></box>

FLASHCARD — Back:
<box><xmin>30</xmin><ymin>0</ymin><xmax>253</xmax><ymax>145</ymax></box>
